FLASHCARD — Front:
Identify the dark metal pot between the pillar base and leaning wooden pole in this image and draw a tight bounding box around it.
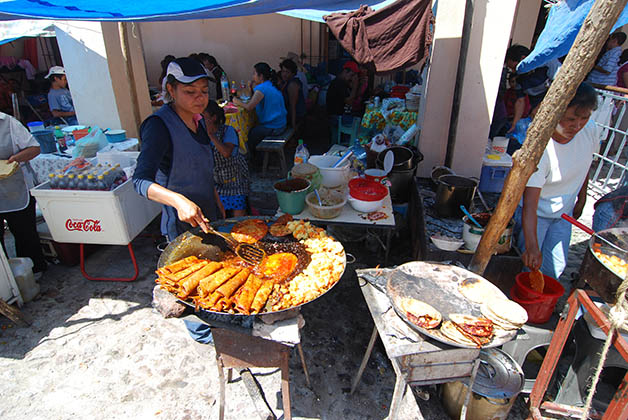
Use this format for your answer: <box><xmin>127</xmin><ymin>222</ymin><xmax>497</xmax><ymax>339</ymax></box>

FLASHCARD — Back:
<box><xmin>435</xmin><ymin>175</ymin><xmax>478</xmax><ymax>218</ymax></box>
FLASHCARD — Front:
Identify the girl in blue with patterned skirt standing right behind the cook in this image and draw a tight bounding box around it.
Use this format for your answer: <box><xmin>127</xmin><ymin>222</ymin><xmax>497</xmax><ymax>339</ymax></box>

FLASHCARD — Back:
<box><xmin>202</xmin><ymin>101</ymin><xmax>249</xmax><ymax>217</ymax></box>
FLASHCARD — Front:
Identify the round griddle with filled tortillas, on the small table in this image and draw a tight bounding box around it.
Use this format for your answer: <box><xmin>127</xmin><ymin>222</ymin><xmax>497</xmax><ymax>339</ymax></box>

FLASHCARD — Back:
<box><xmin>386</xmin><ymin>261</ymin><xmax>517</xmax><ymax>349</ymax></box>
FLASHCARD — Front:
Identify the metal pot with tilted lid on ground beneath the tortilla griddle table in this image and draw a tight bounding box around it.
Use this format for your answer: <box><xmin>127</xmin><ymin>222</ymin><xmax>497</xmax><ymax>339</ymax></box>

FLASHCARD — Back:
<box><xmin>442</xmin><ymin>348</ymin><xmax>525</xmax><ymax>420</ymax></box>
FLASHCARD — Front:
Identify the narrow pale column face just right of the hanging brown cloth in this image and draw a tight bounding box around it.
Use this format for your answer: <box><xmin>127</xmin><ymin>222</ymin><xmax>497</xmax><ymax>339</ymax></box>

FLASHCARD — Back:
<box><xmin>417</xmin><ymin>0</ymin><xmax>464</xmax><ymax>176</ymax></box>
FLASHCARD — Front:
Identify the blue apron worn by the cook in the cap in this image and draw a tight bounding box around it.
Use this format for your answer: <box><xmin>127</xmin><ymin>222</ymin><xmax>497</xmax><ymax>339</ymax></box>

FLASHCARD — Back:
<box><xmin>154</xmin><ymin>105</ymin><xmax>217</xmax><ymax>241</ymax></box>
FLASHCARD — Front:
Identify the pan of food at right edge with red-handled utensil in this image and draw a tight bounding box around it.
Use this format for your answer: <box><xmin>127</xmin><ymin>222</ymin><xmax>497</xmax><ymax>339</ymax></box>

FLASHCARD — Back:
<box><xmin>580</xmin><ymin>228</ymin><xmax>628</xmax><ymax>304</ymax></box>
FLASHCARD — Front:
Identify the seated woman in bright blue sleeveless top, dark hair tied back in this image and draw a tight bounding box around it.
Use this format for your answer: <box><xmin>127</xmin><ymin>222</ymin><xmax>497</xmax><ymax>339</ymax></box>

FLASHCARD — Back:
<box><xmin>233</xmin><ymin>63</ymin><xmax>287</xmax><ymax>156</ymax></box>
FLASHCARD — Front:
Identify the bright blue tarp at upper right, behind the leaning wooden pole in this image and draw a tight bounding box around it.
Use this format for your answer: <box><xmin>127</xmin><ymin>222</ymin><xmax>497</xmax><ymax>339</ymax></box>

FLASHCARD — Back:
<box><xmin>517</xmin><ymin>0</ymin><xmax>628</xmax><ymax>73</ymax></box>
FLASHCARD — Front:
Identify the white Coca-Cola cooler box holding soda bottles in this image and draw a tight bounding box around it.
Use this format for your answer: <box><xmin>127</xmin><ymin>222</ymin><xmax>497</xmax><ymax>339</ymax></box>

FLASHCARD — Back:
<box><xmin>31</xmin><ymin>179</ymin><xmax>161</xmax><ymax>245</ymax></box>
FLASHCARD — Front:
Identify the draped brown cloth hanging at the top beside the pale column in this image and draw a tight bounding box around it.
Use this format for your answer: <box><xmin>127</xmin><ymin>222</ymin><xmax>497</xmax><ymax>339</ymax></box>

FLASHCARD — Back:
<box><xmin>323</xmin><ymin>0</ymin><xmax>433</xmax><ymax>72</ymax></box>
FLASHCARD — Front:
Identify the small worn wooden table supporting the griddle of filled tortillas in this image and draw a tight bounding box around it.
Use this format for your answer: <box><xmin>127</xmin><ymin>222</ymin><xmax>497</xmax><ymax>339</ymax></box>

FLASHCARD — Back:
<box><xmin>351</xmin><ymin>269</ymin><xmax>480</xmax><ymax>420</ymax></box>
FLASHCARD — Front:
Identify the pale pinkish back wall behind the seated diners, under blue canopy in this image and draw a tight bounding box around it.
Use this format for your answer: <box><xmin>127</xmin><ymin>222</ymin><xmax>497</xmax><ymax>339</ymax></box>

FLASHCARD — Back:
<box><xmin>140</xmin><ymin>14</ymin><xmax>319</xmax><ymax>86</ymax></box>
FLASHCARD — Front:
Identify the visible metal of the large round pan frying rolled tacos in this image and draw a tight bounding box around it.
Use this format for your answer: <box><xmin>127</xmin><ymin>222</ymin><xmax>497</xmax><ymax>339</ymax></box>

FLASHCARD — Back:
<box><xmin>157</xmin><ymin>216</ymin><xmax>347</xmax><ymax>317</ymax></box>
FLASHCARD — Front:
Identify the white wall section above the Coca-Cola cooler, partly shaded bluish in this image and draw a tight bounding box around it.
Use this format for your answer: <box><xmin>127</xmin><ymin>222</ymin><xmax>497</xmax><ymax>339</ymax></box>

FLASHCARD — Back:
<box><xmin>55</xmin><ymin>22</ymin><xmax>121</xmax><ymax>129</ymax></box>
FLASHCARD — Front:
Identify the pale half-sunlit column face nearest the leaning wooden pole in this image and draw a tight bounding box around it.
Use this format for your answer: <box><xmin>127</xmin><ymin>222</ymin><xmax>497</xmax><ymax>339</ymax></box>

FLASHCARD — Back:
<box><xmin>452</xmin><ymin>0</ymin><xmax>516</xmax><ymax>176</ymax></box>
